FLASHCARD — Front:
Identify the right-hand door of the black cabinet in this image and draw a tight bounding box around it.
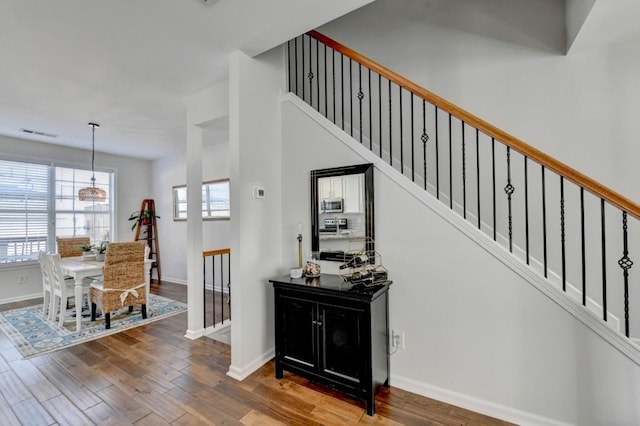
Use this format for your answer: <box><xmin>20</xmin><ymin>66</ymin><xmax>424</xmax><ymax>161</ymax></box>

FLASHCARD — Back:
<box><xmin>318</xmin><ymin>304</ymin><xmax>366</xmax><ymax>384</ymax></box>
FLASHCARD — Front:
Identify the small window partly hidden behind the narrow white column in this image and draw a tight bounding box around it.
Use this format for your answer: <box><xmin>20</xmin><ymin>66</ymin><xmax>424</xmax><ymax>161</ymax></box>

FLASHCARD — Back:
<box><xmin>173</xmin><ymin>179</ymin><xmax>231</xmax><ymax>220</ymax></box>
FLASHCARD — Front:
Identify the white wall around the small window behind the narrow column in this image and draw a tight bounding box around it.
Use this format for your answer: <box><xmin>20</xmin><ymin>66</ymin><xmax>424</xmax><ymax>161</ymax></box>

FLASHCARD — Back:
<box><xmin>151</xmin><ymin>138</ymin><xmax>230</xmax><ymax>284</ymax></box>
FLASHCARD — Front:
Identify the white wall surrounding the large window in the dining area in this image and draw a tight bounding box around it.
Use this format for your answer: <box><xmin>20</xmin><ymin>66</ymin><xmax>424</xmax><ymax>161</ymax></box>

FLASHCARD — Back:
<box><xmin>0</xmin><ymin>136</ymin><xmax>151</xmax><ymax>303</ymax></box>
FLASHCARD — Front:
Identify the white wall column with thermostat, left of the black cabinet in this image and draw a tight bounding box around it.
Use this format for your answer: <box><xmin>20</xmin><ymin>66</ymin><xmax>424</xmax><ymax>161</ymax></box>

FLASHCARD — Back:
<box><xmin>229</xmin><ymin>48</ymin><xmax>285</xmax><ymax>379</ymax></box>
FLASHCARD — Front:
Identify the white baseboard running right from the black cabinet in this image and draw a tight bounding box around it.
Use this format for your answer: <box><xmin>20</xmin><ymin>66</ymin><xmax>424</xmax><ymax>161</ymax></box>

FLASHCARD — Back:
<box><xmin>391</xmin><ymin>374</ymin><xmax>570</xmax><ymax>426</ymax></box>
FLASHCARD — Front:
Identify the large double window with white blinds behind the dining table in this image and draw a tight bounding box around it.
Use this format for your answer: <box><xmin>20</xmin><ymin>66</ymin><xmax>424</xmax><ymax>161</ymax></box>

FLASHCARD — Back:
<box><xmin>0</xmin><ymin>160</ymin><xmax>113</xmax><ymax>264</ymax></box>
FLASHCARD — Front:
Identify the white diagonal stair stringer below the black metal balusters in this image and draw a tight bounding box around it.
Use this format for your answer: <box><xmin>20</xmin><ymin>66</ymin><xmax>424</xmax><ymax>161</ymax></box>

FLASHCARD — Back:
<box><xmin>281</xmin><ymin>93</ymin><xmax>640</xmax><ymax>366</ymax></box>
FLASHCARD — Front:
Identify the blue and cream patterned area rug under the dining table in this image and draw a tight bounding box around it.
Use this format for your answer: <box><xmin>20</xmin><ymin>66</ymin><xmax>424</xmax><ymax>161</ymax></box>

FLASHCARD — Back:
<box><xmin>0</xmin><ymin>294</ymin><xmax>187</xmax><ymax>359</ymax></box>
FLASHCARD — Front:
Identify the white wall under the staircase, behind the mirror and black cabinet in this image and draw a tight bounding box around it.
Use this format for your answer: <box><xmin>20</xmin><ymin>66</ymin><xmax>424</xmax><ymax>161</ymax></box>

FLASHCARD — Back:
<box><xmin>282</xmin><ymin>98</ymin><xmax>640</xmax><ymax>425</ymax></box>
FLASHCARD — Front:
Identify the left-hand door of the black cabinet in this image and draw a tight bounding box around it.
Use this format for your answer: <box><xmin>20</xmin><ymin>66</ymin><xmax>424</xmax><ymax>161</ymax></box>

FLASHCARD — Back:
<box><xmin>277</xmin><ymin>296</ymin><xmax>317</xmax><ymax>368</ymax></box>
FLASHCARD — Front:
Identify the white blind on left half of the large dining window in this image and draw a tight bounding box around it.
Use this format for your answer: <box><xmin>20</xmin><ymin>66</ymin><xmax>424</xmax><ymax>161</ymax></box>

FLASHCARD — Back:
<box><xmin>0</xmin><ymin>160</ymin><xmax>50</xmax><ymax>263</ymax></box>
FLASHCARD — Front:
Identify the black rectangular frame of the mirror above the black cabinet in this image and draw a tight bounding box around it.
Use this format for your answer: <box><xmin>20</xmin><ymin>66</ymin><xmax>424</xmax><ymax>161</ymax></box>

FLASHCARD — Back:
<box><xmin>310</xmin><ymin>163</ymin><xmax>375</xmax><ymax>262</ymax></box>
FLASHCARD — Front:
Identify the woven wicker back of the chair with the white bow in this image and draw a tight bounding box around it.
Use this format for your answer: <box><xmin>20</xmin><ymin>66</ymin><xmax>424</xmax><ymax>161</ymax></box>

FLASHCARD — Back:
<box><xmin>103</xmin><ymin>241</ymin><xmax>147</xmax><ymax>289</ymax></box>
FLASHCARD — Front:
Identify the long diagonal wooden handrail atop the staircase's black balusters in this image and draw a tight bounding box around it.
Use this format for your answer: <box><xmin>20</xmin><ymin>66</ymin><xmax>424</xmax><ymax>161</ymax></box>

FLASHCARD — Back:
<box><xmin>307</xmin><ymin>30</ymin><xmax>640</xmax><ymax>219</ymax></box>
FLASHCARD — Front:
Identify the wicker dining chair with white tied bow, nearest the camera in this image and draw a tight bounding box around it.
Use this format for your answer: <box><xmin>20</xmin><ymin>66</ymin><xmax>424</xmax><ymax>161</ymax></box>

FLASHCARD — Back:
<box><xmin>89</xmin><ymin>241</ymin><xmax>147</xmax><ymax>329</ymax></box>
